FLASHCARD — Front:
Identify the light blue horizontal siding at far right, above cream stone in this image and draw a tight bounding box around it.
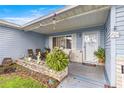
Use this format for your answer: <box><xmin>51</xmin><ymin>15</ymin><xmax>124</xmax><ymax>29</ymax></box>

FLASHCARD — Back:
<box><xmin>116</xmin><ymin>5</ymin><xmax>124</xmax><ymax>55</ymax></box>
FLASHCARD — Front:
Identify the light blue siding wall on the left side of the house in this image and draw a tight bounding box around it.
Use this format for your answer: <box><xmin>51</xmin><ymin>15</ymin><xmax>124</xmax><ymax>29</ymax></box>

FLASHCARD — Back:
<box><xmin>0</xmin><ymin>26</ymin><xmax>46</xmax><ymax>63</ymax></box>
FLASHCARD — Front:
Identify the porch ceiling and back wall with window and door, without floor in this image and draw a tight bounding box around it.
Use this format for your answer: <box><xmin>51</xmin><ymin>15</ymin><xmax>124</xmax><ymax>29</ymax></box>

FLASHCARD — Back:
<box><xmin>23</xmin><ymin>6</ymin><xmax>110</xmax><ymax>65</ymax></box>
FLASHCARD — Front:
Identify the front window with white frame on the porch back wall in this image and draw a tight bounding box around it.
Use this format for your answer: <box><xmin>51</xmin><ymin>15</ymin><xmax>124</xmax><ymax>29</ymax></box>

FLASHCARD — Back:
<box><xmin>53</xmin><ymin>35</ymin><xmax>72</xmax><ymax>49</ymax></box>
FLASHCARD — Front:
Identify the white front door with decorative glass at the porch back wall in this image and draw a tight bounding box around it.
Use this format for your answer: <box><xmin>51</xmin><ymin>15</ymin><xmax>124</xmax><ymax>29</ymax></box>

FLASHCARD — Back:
<box><xmin>83</xmin><ymin>32</ymin><xmax>99</xmax><ymax>63</ymax></box>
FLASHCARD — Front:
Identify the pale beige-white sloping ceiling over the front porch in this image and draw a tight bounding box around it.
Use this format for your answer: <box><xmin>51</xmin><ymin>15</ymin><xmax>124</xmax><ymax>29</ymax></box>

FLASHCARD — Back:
<box><xmin>24</xmin><ymin>6</ymin><xmax>109</xmax><ymax>34</ymax></box>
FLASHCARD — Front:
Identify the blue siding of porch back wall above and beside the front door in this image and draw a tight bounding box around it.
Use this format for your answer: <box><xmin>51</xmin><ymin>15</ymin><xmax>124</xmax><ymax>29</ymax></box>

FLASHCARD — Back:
<box><xmin>49</xmin><ymin>25</ymin><xmax>105</xmax><ymax>50</ymax></box>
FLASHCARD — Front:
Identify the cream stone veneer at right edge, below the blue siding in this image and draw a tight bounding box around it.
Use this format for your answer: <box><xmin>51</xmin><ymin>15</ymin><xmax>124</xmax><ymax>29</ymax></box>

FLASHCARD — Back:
<box><xmin>116</xmin><ymin>56</ymin><xmax>124</xmax><ymax>88</ymax></box>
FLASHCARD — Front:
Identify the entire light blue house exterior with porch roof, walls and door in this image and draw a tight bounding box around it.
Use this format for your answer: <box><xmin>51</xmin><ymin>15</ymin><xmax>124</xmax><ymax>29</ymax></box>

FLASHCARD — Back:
<box><xmin>0</xmin><ymin>5</ymin><xmax>124</xmax><ymax>87</ymax></box>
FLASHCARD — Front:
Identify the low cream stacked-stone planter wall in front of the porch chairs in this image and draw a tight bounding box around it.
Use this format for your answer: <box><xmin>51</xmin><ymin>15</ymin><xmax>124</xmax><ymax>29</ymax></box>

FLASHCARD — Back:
<box><xmin>16</xmin><ymin>60</ymin><xmax>68</xmax><ymax>81</ymax></box>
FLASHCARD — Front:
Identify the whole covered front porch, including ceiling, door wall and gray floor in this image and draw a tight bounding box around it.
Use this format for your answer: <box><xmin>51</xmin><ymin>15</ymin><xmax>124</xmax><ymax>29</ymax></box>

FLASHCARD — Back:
<box><xmin>23</xmin><ymin>6</ymin><xmax>110</xmax><ymax>87</ymax></box>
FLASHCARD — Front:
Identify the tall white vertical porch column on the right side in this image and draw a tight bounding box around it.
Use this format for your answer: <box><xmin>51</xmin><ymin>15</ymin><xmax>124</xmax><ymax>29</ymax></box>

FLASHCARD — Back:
<box><xmin>110</xmin><ymin>6</ymin><xmax>116</xmax><ymax>86</ymax></box>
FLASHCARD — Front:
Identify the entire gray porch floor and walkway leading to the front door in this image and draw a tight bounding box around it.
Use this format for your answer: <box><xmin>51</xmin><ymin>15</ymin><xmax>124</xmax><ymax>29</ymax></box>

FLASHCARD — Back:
<box><xmin>58</xmin><ymin>63</ymin><xmax>106</xmax><ymax>88</ymax></box>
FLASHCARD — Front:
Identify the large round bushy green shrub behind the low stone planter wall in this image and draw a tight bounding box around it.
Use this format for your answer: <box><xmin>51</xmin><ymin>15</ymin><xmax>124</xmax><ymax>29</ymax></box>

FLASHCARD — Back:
<box><xmin>46</xmin><ymin>48</ymin><xmax>69</xmax><ymax>71</ymax></box>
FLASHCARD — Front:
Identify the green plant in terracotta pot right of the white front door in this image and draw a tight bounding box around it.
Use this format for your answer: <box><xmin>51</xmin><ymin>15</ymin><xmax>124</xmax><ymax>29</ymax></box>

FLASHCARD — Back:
<box><xmin>94</xmin><ymin>48</ymin><xmax>105</xmax><ymax>63</ymax></box>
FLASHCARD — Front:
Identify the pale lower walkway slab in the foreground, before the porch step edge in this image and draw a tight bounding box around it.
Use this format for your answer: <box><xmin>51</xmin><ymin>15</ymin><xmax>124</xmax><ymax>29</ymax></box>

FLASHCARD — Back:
<box><xmin>58</xmin><ymin>74</ymin><xmax>104</xmax><ymax>88</ymax></box>
